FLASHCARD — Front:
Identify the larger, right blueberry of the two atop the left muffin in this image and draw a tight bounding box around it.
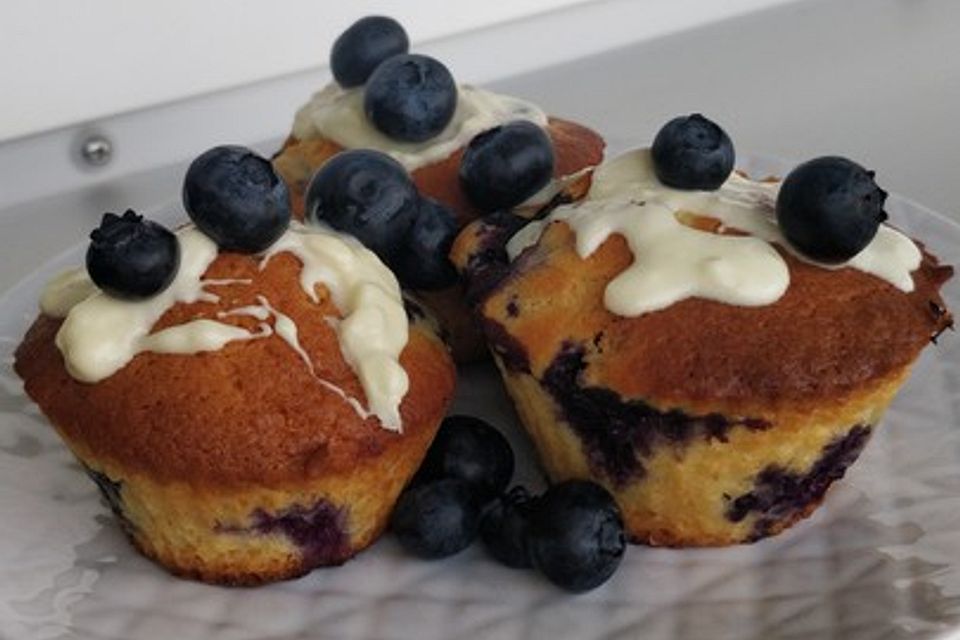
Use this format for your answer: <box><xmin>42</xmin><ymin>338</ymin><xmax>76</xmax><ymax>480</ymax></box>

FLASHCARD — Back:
<box><xmin>183</xmin><ymin>146</ymin><xmax>290</xmax><ymax>253</ymax></box>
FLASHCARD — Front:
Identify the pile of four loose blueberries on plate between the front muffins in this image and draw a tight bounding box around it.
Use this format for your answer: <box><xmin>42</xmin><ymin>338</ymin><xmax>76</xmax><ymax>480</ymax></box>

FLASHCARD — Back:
<box><xmin>390</xmin><ymin>416</ymin><xmax>626</xmax><ymax>593</ymax></box>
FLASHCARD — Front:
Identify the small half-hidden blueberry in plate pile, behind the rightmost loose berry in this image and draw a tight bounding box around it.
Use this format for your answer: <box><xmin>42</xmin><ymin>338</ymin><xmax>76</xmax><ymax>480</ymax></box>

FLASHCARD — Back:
<box><xmin>480</xmin><ymin>486</ymin><xmax>533</xmax><ymax>569</ymax></box>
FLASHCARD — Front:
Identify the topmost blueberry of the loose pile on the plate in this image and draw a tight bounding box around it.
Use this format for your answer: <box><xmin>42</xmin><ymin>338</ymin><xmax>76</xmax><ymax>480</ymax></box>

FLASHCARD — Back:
<box><xmin>416</xmin><ymin>416</ymin><xmax>514</xmax><ymax>502</ymax></box>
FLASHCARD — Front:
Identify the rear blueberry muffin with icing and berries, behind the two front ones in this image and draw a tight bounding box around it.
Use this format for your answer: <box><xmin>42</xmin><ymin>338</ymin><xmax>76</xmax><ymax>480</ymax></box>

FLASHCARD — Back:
<box><xmin>273</xmin><ymin>16</ymin><xmax>604</xmax><ymax>360</ymax></box>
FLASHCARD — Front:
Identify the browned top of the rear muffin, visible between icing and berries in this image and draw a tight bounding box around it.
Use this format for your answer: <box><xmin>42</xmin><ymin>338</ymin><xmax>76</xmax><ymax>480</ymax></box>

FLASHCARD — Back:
<box><xmin>273</xmin><ymin>118</ymin><xmax>605</xmax><ymax>226</ymax></box>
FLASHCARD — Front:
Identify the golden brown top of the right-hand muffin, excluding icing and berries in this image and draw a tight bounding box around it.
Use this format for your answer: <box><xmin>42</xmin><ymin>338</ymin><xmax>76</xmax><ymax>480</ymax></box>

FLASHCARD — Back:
<box><xmin>452</xmin><ymin>192</ymin><xmax>952</xmax><ymax>415</ymax></box>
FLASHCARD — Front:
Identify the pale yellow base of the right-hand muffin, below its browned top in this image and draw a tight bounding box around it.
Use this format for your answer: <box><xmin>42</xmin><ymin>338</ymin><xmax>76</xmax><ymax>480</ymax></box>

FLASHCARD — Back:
<box><xmin>494</xmin><ymin>354</ymin><xmax>910</xmax><ymax>547</ymax></box>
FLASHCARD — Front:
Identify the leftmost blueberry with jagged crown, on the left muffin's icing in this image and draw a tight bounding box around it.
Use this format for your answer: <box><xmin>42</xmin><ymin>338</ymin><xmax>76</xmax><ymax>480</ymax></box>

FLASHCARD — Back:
<box><xmin>87</xmin><ymin>209</ymin><xmax>180</xmax><ymax>300</ymax></box>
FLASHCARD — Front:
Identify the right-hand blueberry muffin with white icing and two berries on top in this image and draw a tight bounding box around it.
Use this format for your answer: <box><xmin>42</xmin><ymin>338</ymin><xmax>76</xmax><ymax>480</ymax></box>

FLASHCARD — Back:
<box><xmin>452</xmin><ymin>116</ymin><xmax>952</xmax><ymax>546</ymax></box>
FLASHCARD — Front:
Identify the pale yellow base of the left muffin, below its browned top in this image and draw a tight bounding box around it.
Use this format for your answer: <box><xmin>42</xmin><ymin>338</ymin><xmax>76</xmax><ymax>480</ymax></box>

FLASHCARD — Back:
<box><xmin>70</xmin><ymin>412</ymin><xmax>439</xmax><ymax>586</ymax></box>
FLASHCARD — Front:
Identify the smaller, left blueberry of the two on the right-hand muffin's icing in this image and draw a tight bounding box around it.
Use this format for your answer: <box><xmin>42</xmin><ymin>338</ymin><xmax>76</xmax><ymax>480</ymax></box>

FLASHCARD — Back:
<box><xmin>650</xmin><ymin>113</ymin><xmax>735</xmax><ymax>191</ymax></box>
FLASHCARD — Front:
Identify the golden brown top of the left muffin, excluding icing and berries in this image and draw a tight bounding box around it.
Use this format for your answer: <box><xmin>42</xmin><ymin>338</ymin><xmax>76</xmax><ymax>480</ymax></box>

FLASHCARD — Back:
<box><xmin>15</xmin><ymin>253</ymin><xmax>455</xmax><ymax>485</ymax></box>
